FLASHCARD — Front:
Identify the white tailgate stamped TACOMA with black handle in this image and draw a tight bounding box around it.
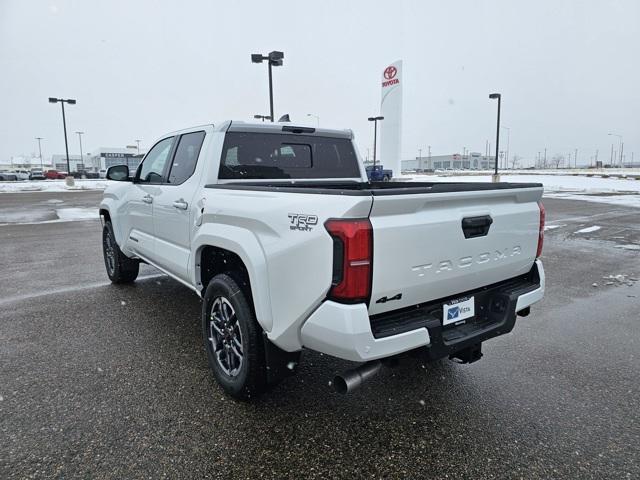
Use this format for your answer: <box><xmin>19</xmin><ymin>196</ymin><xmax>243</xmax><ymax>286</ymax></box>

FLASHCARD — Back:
<box><xmin>369</xmin><ymin>187</ymin><xmax>542</xmax><ymax>315</ymax></box>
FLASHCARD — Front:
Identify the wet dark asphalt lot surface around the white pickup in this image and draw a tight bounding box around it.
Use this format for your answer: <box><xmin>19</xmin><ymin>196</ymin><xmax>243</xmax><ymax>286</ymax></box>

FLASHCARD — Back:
<box><xmin>0</xmin><ymin>192</ymin><xmax>640</xmax><ymax>479</ymax></box>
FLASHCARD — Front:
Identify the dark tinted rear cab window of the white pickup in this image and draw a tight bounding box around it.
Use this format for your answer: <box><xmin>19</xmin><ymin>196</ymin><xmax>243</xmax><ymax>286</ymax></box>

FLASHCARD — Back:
<box><xmin>218</xmin><ymin>132</ymin><xmax>360</xmax><ymax>180</ymax></box>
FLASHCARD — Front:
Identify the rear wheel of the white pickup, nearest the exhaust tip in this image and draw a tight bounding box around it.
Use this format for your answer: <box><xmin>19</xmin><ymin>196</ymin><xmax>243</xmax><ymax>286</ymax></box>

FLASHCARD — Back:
<box><xmin>202</xmin><ymin>274</ymin><xmax>267</xmax><ymax>400</ymax></box>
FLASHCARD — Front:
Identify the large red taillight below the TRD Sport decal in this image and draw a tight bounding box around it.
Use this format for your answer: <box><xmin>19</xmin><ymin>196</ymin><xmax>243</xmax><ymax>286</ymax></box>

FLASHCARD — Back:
<box><xmin>324</xmin><ymin>218</ymin><xmax>373</xmax><ymax>303</ymax></box>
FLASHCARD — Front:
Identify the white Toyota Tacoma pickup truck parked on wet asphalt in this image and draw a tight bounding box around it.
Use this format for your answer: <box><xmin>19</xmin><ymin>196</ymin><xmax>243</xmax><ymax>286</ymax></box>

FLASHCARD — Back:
<box><xmin>100</xmin><ymin>121</ymin><xmax>544</xmax><ymax>399</ymax></box>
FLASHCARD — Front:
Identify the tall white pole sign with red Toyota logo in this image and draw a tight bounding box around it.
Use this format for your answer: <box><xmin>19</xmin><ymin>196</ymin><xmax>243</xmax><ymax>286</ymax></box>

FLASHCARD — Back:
<box><xmin>380</xmin><ymin>60</ymin><xmax>402</xmax><ymax>177</ymax></box>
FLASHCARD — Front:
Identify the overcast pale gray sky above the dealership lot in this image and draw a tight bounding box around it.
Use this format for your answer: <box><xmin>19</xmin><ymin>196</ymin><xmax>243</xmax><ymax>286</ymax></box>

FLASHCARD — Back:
<box><xmin>0</xmin><ymin>0</ymin><xmax>640</xmax><ymax>167</ymax></box>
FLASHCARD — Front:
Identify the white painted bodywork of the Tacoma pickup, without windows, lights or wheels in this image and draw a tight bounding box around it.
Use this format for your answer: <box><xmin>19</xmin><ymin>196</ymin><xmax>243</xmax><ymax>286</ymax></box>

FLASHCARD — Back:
<box><xmin>100</xmin><ymin>123</ymin><xmax>544</xmax><ymax>361</ymax></box>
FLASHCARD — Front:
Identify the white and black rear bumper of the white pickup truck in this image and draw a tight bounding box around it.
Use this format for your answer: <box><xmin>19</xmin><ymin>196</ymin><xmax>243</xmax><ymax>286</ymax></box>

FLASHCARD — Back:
<box><xmin>300</xmin><ymin>260</ymin><xmax>545</xmax><ymax>362</ymax></box>
